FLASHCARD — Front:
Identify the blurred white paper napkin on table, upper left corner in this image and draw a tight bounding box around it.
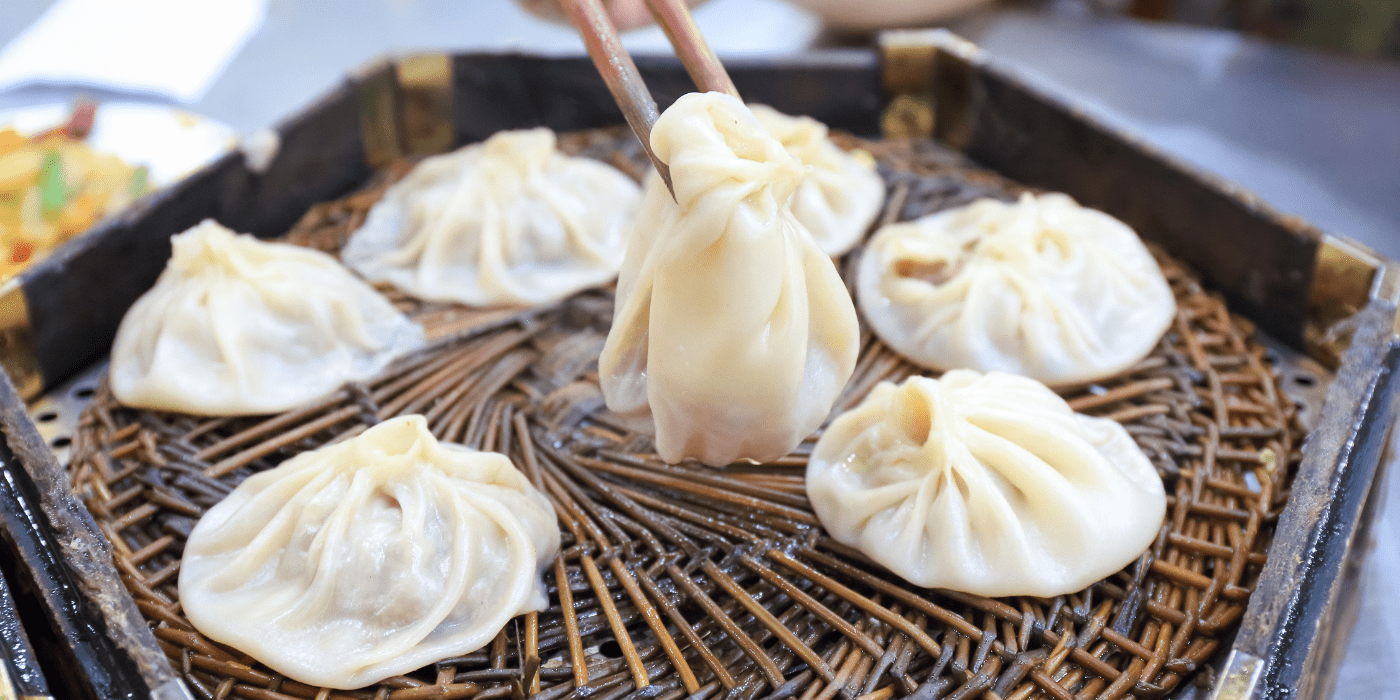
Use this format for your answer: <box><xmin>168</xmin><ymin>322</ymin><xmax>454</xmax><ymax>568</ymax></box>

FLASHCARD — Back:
<box><xmin>0</xmin><ymin>0</ymin><xmax>267</xmax><ymax>104</ymax></box>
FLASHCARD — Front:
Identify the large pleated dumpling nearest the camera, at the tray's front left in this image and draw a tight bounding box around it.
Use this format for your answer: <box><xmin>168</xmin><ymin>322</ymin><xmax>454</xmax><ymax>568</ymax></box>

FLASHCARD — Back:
<box><xmin>179</xmin><ymin>416</ymin><xmax>559</xmax><ymax>689</ymax></box>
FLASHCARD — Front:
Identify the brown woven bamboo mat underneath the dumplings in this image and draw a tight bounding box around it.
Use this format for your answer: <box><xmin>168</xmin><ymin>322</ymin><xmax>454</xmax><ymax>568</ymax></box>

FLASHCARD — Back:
<box><xmin>70</xmin><ymin>132</ymin><xmax>1302</xmax><ymax>700</ymax></box>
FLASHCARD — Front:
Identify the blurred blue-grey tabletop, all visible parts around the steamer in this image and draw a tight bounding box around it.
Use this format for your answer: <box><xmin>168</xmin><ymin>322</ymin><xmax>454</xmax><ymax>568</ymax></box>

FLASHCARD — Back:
<box><xmin>0</xmin><ymin>0</ymin><xmax>1400</xmax><ymax>699</ymax></box>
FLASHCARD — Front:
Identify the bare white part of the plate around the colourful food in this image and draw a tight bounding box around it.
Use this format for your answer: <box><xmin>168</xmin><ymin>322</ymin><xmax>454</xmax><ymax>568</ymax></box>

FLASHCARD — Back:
<box><xmin>0</xmin><ymin>102</ymin><xmax>238</xmax><ymax>188</ymax></box>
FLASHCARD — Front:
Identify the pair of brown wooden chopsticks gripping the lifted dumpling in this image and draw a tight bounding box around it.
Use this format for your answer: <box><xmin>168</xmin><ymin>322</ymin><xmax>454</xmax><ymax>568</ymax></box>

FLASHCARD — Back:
<box><xmin>560</xmin><ymin>0</ymin><xmax>739</xmax><ymax>197</ymax></box>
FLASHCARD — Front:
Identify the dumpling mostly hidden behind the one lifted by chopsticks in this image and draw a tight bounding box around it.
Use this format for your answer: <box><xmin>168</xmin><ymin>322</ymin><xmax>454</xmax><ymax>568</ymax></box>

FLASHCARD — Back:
<box><xmin>749</xmin><ymin>105</ymin><xmax>885</xmax><ymax>258</ymax></box>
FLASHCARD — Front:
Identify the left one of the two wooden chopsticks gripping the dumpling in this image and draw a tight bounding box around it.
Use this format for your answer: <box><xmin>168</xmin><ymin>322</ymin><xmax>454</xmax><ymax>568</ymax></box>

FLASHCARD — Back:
<box><xmin>559</xmin><ymin>0</ymin><xmax>676</xmax><ymax>197</ymax></box>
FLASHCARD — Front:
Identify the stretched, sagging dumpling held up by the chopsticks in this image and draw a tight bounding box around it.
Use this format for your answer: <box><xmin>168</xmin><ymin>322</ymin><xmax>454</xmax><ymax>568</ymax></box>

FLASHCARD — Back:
<box><xmin>599</xmin><ymin>92</ymin><xmax>858</xmax><ymax>465</ymax></box>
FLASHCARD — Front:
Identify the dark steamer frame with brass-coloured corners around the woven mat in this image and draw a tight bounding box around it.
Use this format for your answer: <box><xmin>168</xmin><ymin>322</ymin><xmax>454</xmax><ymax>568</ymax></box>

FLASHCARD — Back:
<box><xmin>0</xmin><ymin>32</ymin><xmax>1400</xmax><ymax>700</ymax></box>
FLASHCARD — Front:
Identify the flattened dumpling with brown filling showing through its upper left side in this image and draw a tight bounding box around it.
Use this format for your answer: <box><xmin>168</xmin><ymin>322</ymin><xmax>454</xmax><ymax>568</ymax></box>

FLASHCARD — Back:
<box><xmin>855</xmin><ymin>195</ymin><xmax>1176</xmax><ymax>385</ymax></box>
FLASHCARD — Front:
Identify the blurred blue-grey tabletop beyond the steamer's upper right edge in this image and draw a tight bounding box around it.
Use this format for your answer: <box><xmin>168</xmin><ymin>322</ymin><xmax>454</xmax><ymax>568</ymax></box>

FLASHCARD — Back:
<box><xmin>958</xmin><ymin>13</ymin><xmax>1400</xmax><ymax>259</ymax></box>
